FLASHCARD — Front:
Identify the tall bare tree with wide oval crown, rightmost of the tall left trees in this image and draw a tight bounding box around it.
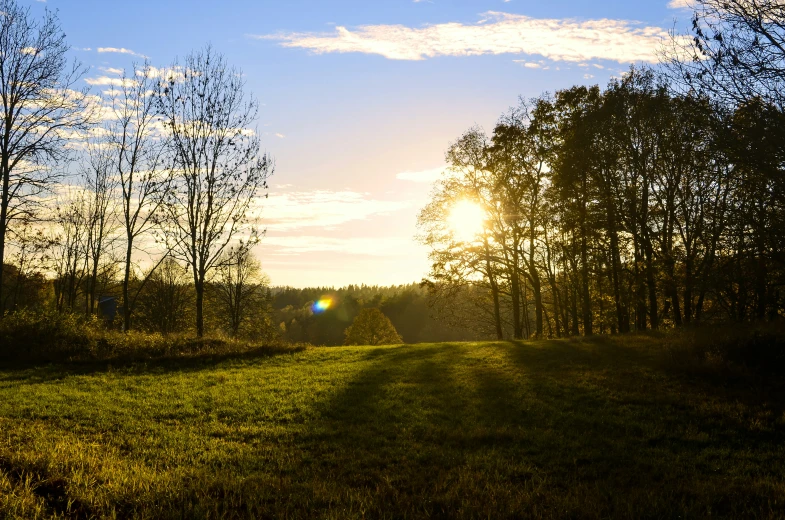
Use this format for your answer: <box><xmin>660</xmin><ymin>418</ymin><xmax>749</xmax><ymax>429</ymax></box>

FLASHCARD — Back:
<box><xmin>158</xmin><ymin>47</ymin><xmax>273</xmax><ymax>337</ymax></box>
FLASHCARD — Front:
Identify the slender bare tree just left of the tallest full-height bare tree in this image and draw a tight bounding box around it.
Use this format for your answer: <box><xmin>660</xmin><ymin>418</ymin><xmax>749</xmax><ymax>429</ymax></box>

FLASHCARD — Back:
<box><xmin>106</xmin><ymin>63</ymin><xmax>171</xmax><ymax>331</ymax></box>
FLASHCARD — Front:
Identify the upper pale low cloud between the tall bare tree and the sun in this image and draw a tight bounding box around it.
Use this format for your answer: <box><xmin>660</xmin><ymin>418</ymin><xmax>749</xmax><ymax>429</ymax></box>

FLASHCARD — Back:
<box><xmin>260</xmin><ymin>190</ymin><xmax>411</xmax><ymax>232</ymax></box>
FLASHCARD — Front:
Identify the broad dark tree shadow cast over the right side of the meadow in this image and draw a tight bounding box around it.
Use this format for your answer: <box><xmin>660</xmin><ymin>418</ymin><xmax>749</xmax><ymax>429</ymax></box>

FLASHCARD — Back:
<box><xmin>290</xmin><ymin>336</ymin><xmax>785</xmax><ymax>517</ymax></box>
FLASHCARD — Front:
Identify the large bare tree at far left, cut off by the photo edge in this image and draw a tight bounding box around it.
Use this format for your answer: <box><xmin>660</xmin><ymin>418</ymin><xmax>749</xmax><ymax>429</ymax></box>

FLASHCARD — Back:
<box><xmin>0</xmin><ymin>0</ymin><xmax>94</xmax><ymax>318</ymax></box>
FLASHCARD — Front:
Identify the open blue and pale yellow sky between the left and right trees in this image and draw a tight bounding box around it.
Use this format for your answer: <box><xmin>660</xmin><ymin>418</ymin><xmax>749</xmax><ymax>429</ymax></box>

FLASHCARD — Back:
<box><xmin>30</xmin><ymin>0</ymin><xmax>690</xmax><ymax>287</ymax></box>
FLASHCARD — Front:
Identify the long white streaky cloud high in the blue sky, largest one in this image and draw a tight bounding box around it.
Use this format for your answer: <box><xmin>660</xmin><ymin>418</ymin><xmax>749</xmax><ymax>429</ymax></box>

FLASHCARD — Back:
<box><xmin>260</xmin><ymin>12</ymin><xmax>668</xmax><ymax>63</ymax></box>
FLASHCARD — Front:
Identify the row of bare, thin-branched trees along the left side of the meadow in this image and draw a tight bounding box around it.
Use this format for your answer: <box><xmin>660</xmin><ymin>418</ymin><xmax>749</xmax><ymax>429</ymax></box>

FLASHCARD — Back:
<box><xmin>0</xmin><ymin>0</ymin><xmax>273</xmax><ymax>336</ymax></box>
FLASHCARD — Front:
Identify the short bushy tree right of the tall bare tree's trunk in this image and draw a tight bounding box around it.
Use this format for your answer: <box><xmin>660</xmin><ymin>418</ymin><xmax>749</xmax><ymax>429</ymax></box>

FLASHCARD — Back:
<box><xmin>213</xmin><ymin>243</ymin><xmax>269</xmax><ymax>337</ymax></box>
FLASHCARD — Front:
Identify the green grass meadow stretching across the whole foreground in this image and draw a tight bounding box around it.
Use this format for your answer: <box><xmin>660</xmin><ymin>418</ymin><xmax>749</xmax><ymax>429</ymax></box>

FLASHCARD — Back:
<box><xmin>0</xmin><ymin>336</ymin><xmax>785</xmax><ymax>518</ymax></box>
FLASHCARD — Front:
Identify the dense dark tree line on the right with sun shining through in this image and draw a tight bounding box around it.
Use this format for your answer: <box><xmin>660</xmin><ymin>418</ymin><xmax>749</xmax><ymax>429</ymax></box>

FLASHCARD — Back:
<box><xmin>418</xmin><ymin>0</ymin><xmax>785</xmax><ymax>339</ymax></box>
